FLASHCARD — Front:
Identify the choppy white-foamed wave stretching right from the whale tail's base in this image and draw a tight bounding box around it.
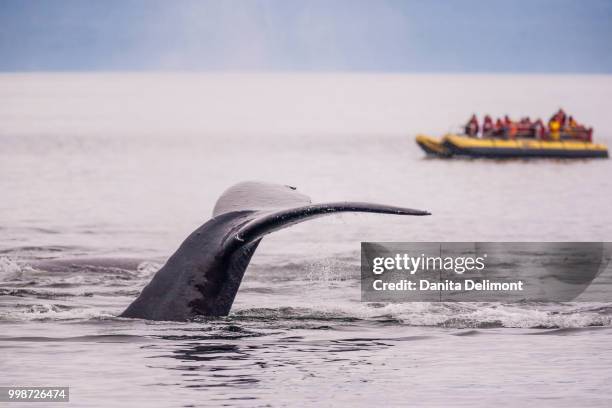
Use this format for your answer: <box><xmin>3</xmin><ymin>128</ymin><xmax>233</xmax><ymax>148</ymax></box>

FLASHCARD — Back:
<box><xmin>232</xmin><ymin>303</ymin><xmax>612</xmax><ymax>329</ymax></box>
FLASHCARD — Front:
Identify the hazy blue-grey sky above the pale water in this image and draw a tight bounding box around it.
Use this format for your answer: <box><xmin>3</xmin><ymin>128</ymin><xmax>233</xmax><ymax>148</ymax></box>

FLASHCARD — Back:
<box><xmin>0</xmin><ymin>0</ymin><xmax>612</xmax><ymax>73</ymax></box>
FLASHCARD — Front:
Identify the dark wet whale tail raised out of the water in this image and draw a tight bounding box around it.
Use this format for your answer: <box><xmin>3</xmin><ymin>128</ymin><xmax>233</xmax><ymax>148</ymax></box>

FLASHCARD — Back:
<box><xmin>121</xmin><ymin>182</ymin><xmax>429</xmax><ymax>321</ymax></box>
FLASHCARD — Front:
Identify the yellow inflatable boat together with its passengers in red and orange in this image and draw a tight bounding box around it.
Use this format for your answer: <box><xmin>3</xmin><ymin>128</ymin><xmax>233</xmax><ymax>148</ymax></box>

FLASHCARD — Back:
<box><xmin>416</xmin><ymin>110</ymin><xmax>608</xmax><ymax>159</ymax></box>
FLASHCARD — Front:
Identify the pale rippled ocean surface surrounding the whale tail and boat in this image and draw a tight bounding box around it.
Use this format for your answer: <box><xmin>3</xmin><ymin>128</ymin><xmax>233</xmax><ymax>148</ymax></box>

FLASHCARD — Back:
<box><xmin>0</xmin><ymin>73</ymin><xmax>612</xmax><ymax>408</ymax></box>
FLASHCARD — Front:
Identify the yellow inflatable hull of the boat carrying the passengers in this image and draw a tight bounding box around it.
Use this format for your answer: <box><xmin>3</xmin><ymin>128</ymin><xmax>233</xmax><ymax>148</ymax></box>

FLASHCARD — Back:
<box><xmin>416</xmin><ymin>134</ymin><xmax>608</xmax><ymax>159</ymax></box>
